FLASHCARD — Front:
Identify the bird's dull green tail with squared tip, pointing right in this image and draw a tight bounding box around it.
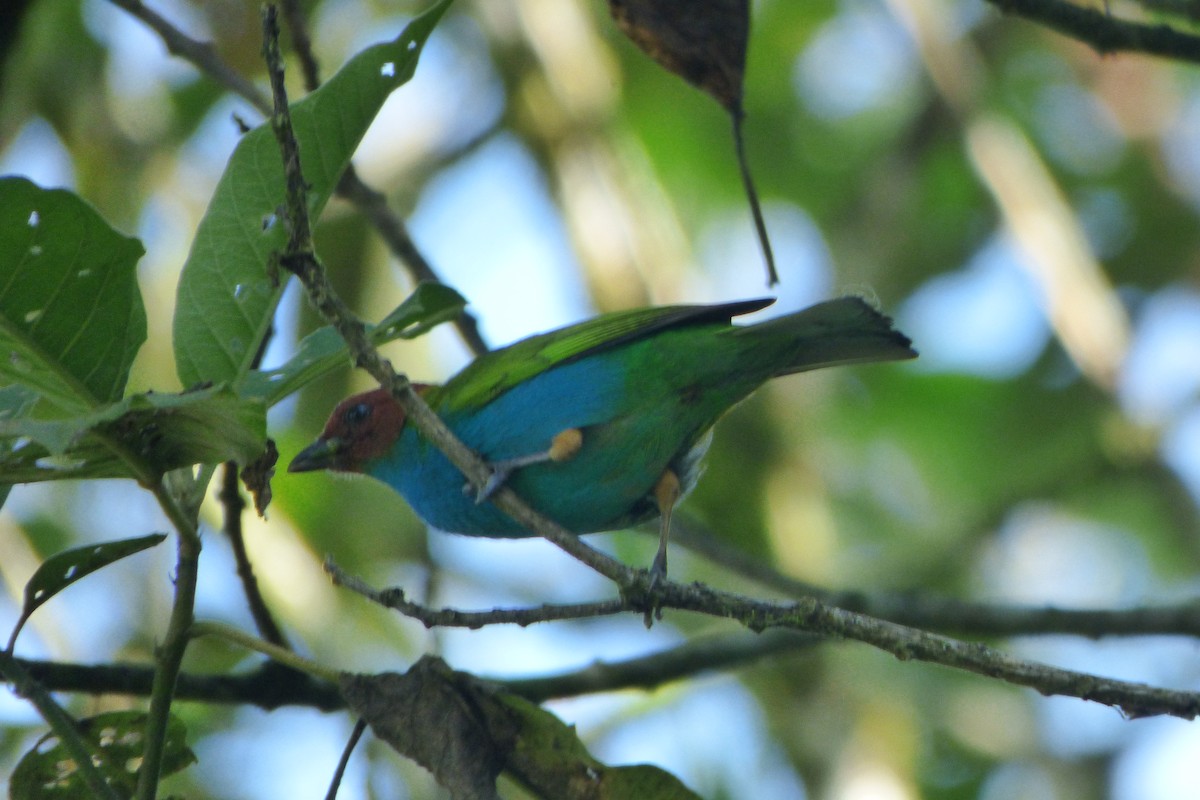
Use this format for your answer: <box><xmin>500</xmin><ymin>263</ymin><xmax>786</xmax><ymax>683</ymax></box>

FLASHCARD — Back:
<box><xmin>734</xmin><ymin>297</ymin><xmax>917</xmax><ymax>377</ymax></box>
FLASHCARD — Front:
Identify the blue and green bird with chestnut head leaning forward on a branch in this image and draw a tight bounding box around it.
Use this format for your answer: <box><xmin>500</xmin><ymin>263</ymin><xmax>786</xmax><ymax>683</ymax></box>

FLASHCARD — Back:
<box><xmin>288</xmin><ymin>296</ymin><xmax>917</xmax><ymax>585</ymax></box>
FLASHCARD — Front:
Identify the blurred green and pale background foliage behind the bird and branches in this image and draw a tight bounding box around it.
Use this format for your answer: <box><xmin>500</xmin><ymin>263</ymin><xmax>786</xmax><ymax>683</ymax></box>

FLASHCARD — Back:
<box><xmin>0</xmin><ymin>0</ymin><xmax>1200</xmax><ymax>800</ymax></box>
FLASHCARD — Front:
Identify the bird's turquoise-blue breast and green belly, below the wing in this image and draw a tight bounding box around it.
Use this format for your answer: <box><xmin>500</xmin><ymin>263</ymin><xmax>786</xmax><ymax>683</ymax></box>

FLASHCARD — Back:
<box><xmin>372</xmin><ymin>345</ymin><xmax>714</xmax><ymax>537</ymax></box>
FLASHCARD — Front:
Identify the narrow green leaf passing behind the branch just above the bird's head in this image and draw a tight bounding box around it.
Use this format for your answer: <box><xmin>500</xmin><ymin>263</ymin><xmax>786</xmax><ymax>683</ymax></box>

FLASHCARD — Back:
<box><xmin>241</xmin><ymin>283</ymin><xmax>467</xmax><ymax>407</ymax></box>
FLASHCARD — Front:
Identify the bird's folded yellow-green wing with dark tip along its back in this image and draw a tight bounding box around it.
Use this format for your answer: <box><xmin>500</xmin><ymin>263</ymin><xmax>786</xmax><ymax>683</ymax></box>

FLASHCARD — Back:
<box><xmin>428</xmin><ymin>297</ymin><xmax>775</xmax><ymax>410</ymax></box>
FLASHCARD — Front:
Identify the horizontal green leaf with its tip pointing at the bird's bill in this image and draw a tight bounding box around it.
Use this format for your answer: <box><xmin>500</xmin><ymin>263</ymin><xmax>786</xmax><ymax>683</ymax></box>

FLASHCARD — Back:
<box><xmin>0</xmin><ymin>387</ymin><xmax>266</xmax><ymax>483</ymax></box>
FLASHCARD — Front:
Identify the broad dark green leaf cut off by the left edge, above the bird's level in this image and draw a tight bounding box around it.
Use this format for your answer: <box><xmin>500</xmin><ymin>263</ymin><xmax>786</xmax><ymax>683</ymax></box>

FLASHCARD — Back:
<box><xmin>0</xmin><ymin>178</ymin><xmax>146</xmax><ymax>411</ymax></box>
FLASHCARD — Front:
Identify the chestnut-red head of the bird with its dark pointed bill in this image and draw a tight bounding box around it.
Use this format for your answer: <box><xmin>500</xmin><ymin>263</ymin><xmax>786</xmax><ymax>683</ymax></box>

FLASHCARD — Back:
<box><xmin>288</xmin><ymin>384</ymin><xmax>426</xmax><ymax>473</ymax></box>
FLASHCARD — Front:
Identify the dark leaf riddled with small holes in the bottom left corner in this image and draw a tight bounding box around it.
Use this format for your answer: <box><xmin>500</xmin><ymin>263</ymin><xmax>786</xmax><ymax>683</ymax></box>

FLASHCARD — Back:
<box><xmin>8</xmin><ymin>711</ymin><xmax>196</xmax><ymax>800</ymax></box>
